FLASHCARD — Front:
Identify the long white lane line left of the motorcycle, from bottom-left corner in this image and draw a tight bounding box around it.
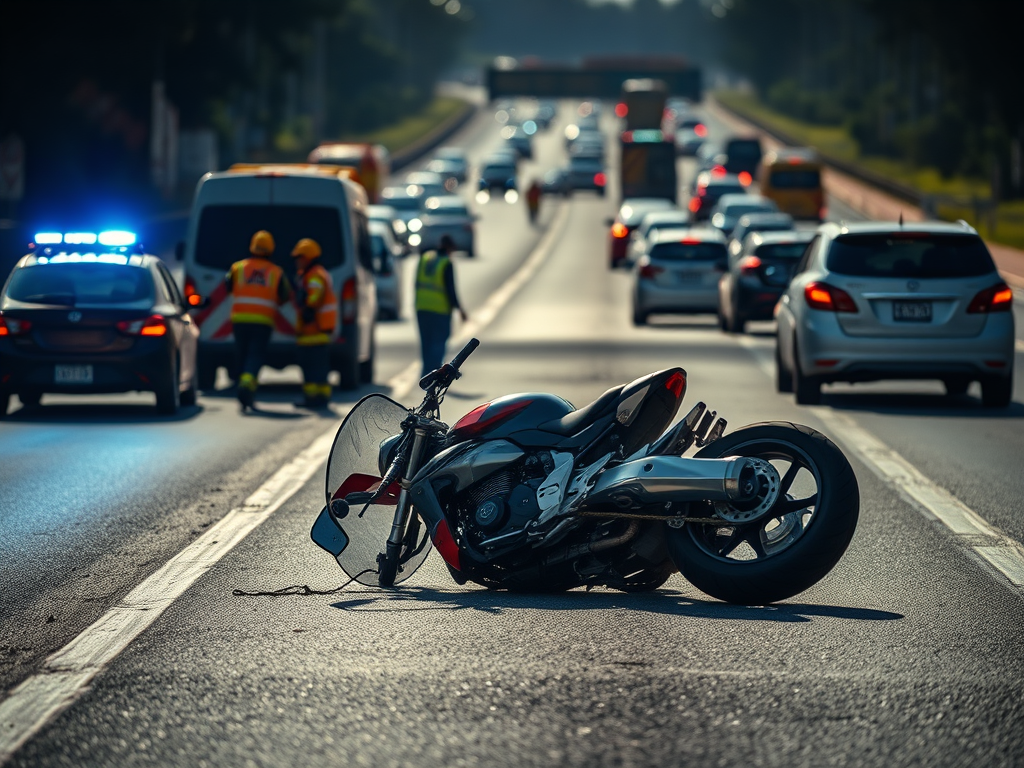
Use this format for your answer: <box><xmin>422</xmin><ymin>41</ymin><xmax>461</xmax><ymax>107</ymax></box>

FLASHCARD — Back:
<box><xmin>0</xmin><ymin>205</ymin><xmax>568</xmax><ymax>765</ymax></box>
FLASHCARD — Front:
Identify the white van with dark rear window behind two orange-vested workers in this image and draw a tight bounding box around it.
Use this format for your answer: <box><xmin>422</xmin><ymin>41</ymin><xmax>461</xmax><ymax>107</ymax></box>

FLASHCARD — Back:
<box><xmin>179</xmin><ymin>164</ymin><xmax>377</xmax><ymax>389</ymax></box>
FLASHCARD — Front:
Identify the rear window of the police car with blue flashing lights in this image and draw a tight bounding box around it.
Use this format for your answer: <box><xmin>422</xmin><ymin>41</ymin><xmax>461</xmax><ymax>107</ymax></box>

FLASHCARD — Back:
<box><xmin>7</xmin><ymin>262</ymin><xmax>155</xmax><ymax>306</ymax></box>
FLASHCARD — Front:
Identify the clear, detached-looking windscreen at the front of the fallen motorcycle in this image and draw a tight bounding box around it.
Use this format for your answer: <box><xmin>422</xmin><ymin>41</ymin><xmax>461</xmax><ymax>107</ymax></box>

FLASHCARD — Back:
<box><xmin>327</xmin><ymin>394</ymin><xmax>430</xmax><ymax>586</ymax></box>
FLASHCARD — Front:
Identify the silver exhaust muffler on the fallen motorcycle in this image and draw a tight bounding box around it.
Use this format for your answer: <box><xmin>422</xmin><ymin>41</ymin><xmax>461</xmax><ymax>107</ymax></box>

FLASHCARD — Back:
<box><xmin>585</xmin><ymin>456</ymin><xmax>759</xmax><ymax>509</ymax></box>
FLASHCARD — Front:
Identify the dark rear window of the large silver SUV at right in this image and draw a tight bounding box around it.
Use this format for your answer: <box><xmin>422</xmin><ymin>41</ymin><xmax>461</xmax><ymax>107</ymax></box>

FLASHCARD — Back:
<box><xmin>825</xmin><ymin>232</ymin><xmax>995</xmax><ymax>278</ymax></box>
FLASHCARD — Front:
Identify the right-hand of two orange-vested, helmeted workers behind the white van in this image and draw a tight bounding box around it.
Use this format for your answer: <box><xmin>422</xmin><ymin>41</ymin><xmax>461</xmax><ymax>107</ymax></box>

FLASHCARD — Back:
<box><xmin>292</xmin><ymin>238</ymin><xmax>338</xmax><ymax>409</ymax></box>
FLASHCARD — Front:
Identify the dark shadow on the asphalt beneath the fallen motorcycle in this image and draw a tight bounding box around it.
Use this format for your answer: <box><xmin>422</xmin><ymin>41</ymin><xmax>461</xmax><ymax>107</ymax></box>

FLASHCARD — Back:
<box><xmin>332</xmin><ymin>587</ymin><xmax>903</xmax><ymax>624</ymax></box>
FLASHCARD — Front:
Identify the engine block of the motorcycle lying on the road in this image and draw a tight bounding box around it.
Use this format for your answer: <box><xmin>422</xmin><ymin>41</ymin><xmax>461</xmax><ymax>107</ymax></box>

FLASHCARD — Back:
<box><xmin>458</xmin><ymin>451</ymin><xmax>555</xmax><ymax>545</ymax></box>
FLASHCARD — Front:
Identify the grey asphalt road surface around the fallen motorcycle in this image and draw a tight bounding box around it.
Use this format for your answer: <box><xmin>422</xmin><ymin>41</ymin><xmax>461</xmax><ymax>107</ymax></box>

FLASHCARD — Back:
<box><xmin>0</xmin><ymin>99</ymin><xmax>1024</xmax><ymax>766</ymax></box>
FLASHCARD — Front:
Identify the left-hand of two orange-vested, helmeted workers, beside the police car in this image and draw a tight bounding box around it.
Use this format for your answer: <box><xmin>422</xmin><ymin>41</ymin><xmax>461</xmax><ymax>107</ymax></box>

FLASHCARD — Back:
<box><xmin>224</xmin><ymin>229</ymin><xmax>292</xmax><ymax>412</ymax></box>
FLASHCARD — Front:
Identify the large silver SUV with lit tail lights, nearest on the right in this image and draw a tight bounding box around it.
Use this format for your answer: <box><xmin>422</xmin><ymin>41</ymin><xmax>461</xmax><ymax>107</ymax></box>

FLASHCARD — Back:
<box><xmin>775</xmin><ymin>221</ymin><xmax>1014</xmax><ymax>408</ymax></box>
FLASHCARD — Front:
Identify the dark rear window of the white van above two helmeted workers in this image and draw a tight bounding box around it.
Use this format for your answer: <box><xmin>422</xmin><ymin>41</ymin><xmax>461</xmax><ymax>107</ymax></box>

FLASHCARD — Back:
<box><xmin>196</xmin><ymin>205</ymin><xmax>346</xmax><ymax>273</ymax></box>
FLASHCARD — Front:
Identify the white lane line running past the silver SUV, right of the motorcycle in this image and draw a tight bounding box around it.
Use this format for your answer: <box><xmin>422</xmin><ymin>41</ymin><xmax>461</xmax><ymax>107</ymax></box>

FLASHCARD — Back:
<box><xmin>739</xmin><ymin>336</ymin><xmax>1024</xmax><ymax>587</ymax></box>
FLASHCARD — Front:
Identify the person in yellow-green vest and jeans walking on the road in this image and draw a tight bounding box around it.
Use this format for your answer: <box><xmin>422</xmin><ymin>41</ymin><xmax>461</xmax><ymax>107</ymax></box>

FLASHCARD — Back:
<box><xmin>416</xmin><ymin>234</ymin><xmax>468</xmax><ymax>376</ymax></box>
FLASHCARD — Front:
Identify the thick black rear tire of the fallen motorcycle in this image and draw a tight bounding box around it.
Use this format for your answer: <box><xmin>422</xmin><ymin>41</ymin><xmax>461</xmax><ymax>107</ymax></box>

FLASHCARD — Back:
<box><xmin>667</xmin><ymin>422</ymin><xmax>860</xmax><ymax>605</ymax></box>
